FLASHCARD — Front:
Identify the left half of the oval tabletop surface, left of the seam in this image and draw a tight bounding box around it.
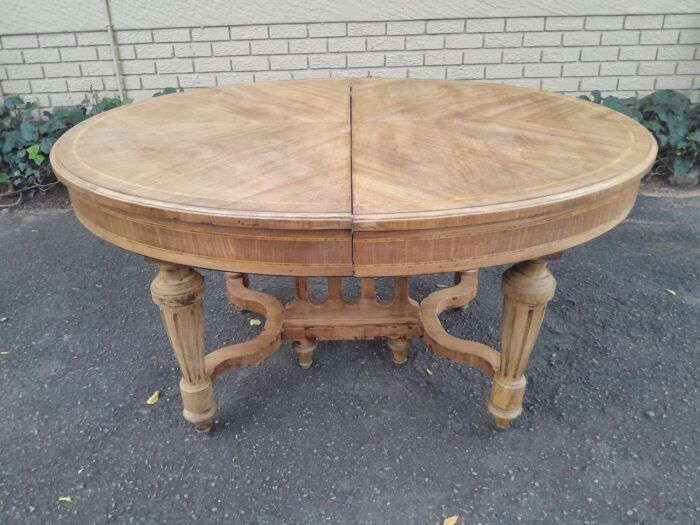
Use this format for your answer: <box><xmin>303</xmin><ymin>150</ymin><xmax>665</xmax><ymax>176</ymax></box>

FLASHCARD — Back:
<box><xmin>53</xmin><ymin>80</ymin><xmax>351</xmax><ymax>225</ymax></box>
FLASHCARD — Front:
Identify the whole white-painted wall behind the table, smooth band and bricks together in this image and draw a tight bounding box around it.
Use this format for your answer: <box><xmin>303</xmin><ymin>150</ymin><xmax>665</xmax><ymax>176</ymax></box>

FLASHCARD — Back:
<box><xmin>0</xmin><ymin>0</ymin><xmax>700</xmax><ymax>107</ymax></box>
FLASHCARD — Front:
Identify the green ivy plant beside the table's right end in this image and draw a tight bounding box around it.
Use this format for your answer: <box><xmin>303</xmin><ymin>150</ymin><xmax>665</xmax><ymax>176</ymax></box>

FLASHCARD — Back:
<box><xmin>581</xmin><ymin>89</ymin><xmax>700</xmax><ymax>185</ymax></box>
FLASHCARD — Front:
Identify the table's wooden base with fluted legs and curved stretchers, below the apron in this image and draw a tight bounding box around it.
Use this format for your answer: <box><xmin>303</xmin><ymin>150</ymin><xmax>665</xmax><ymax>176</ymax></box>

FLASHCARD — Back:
<box><xmin>151</xmin><ymin>257</ymin><xmax>558</xmax><ymax>430</ymax></box>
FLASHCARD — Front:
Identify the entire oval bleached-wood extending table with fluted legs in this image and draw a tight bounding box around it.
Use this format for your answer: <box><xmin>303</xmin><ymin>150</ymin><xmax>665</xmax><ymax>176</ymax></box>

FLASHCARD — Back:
<box><xmin>51</xmin><ymin>79</ymin><xmax>656</xmax><ymax>430</ymax></box>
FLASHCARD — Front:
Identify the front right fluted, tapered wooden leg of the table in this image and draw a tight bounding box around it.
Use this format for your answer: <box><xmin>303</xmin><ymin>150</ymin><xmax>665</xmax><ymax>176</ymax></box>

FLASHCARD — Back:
<box><xmin>488</xmin><ymin>259</ymin><xmax>556</xmax><ymax>428</ymax></box>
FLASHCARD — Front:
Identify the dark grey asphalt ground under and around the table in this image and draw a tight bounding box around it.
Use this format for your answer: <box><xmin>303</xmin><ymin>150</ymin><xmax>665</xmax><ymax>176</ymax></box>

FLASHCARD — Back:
<box><xmin>0</xmin><ymin>183</ymin><xmax>700</xmax><ymax>525</ymax></box>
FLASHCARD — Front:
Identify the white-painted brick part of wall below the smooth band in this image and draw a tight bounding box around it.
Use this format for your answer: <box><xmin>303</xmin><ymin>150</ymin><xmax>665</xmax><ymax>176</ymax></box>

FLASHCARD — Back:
<box><xmin>0</xmin><ymin>14</ymin><xmax>700</xmax><ymax>107</ymax></box>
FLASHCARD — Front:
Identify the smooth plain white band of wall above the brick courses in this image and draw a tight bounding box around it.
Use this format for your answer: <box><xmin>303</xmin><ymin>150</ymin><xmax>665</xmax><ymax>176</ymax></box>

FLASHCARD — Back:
<box><xmin>0</xmin><ymin>0</ymin><xmax>700</xmax><ymax>34</ymax></box>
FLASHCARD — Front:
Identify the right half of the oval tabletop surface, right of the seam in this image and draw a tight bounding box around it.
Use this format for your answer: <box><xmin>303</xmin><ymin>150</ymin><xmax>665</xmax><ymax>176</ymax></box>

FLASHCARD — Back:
<box><xmin>352</xmin><ymin>79</ymin><xmax>655</xmax><ymax>224</ymax></box>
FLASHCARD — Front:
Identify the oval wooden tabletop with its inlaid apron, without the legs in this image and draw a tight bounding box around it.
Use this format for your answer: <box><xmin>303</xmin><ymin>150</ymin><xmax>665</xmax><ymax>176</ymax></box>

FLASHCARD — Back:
<box><xmin>51</xmin><ymin>79</ymin><xmax>656</xmax><ymax>276</ymax></box>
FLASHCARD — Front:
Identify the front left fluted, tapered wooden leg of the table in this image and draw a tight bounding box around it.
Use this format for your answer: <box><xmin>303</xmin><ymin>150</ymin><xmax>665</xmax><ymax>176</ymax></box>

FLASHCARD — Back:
<box><xmin>151</xmin><ymin>262</ymin><xmax>216</xmax><ymax>432</ymax></box>
